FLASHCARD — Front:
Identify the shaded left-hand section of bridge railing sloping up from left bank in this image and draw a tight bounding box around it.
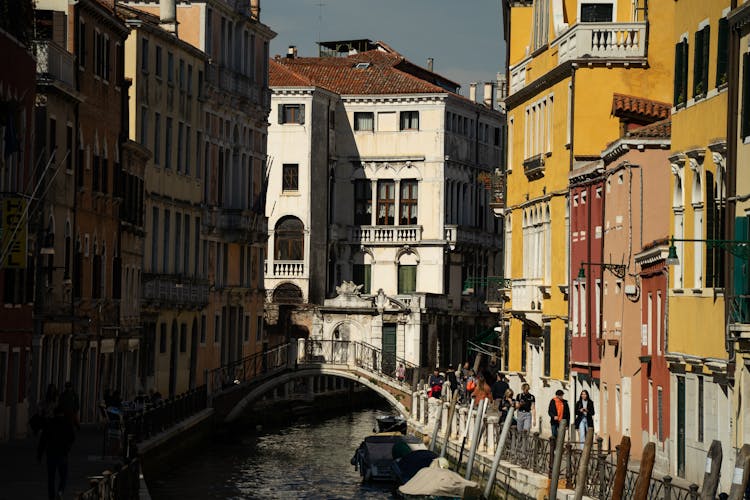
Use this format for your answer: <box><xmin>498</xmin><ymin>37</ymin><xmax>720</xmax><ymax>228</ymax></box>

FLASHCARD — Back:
<box><xmin>206</xmin><ymin>343</ymin><xmax>290</xmax><ymax>394</ymax></box>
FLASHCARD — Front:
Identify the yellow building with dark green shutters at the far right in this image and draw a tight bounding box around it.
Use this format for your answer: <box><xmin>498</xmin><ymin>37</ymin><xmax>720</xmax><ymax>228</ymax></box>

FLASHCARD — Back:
<box><xmin>664</xmin><ymin>0</ymin><xmax>734</xmax><ymax>490</ymax></box>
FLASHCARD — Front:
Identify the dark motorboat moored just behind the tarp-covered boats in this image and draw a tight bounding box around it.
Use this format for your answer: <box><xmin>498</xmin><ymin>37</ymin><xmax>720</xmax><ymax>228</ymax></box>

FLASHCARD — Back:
<box><xmin>351</xmin><ymin>432</ymin><xmax>427</xmax><ymax>481</ymax></box>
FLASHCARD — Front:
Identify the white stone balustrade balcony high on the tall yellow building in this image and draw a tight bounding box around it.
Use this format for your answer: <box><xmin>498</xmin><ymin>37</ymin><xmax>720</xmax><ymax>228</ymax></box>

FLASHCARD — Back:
<box><xmin>557</xmin><ymin>23</ymin><xmax>646</xmax><ymax>64</ymax></box>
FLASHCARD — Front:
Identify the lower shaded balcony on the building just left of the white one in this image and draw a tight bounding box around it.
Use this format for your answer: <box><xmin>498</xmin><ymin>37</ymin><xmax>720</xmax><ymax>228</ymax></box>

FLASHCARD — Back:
<box><xmin>201</xmin><ymin>207</ymin><xmax>268</xmax><ymax>244</ymax></box>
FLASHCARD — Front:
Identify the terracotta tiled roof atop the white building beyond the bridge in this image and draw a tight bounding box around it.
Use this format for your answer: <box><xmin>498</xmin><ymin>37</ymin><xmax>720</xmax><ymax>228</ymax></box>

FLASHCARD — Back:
<box><xmin>270</xmin><ymin>50</ymin><xmax>456</xmax><ymax>95</ymax></box>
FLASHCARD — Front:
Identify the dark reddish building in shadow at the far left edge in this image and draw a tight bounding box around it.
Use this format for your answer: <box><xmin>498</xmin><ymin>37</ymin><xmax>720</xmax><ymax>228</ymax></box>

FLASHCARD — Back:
<box><xmin>0</xmin><ymin>0</ymin><xmax>36</xmax><ymax>441</ymax></box>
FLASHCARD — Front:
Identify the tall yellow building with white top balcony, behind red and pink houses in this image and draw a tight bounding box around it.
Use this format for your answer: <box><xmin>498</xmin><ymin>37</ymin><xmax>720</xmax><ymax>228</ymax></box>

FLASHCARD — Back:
<box><xmin>504</xmin><ymin>0</ymin><xmax>674</xmax><ymax>432</ymax></box>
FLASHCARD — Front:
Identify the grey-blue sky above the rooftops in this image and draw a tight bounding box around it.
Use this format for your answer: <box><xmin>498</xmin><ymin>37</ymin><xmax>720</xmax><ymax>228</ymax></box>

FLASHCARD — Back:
<box><xmin>260</xmin><ymin>0</ymin><xmax>505</xmax><ymax>95</ymax></box>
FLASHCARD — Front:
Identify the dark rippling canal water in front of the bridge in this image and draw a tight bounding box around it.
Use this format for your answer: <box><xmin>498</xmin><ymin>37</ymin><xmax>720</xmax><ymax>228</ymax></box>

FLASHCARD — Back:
<box><xmin>146</xmin><ymin>409</ymin><xmax>402</xmax><ymax>500</ymax></box>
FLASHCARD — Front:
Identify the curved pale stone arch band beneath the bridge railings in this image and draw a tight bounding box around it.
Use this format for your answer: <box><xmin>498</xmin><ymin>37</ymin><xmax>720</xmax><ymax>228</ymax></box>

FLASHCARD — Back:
<box><xmin>225</xmin><ymin>366</ymin><xmax>410</xmax><ymax>423</ymax></box>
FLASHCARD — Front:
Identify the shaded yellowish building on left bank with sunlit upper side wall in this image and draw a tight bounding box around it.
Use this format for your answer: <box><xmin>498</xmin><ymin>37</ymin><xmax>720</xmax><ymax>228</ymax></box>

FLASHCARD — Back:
<box><xmin>120</xmin><ymin>6</ymin><xmax>208</xmax><ymax>397</ymax></box>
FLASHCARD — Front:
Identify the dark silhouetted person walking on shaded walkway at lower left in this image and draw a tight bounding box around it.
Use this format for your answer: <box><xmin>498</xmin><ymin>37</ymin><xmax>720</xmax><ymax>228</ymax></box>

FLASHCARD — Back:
<box><xmin>37</xmin><ymin>406</ymin><xmax>75</xmax><ymax>500</ymax></box>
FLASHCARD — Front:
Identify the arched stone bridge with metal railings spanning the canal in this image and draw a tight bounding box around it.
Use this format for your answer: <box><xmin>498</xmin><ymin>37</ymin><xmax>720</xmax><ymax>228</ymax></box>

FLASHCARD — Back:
<box><xmin>208</xmin><ymin>339</ymin><xmax>415</xmax><ymax>423</ymax></box>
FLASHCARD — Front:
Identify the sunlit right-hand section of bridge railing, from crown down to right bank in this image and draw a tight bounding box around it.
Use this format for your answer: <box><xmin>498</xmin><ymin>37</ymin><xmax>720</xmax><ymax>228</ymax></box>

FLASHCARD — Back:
<box><xmin>297</xmin><ymin>339</ymin><xmax>417</xmax><ymax>384</ymax></box>
